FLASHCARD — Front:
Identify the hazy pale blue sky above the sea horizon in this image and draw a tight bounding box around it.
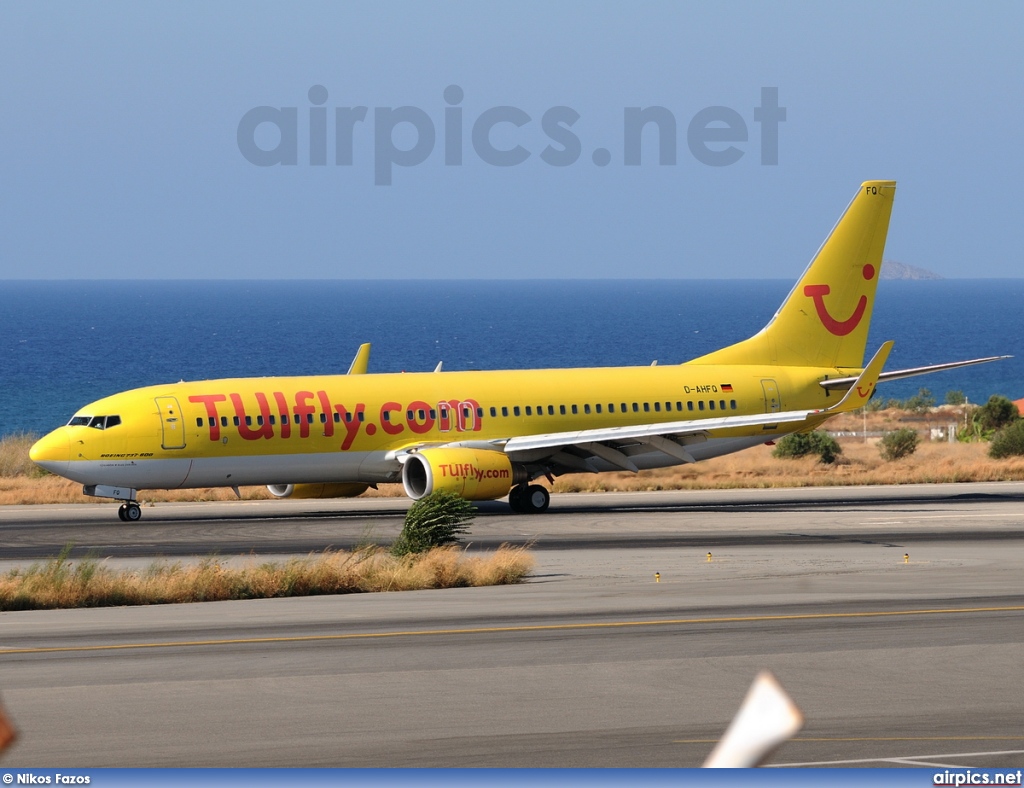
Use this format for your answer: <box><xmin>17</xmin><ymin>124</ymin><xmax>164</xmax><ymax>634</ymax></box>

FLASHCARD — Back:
<box><xmin>0</xmin><ymin>0</ymin><xmax>1024</xmax><ymax>278</ymax></box>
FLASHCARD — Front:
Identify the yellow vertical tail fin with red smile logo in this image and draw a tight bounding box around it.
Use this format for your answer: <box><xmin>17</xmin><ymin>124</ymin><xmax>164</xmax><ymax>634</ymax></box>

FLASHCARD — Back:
<box><xmin>690</xmin><ymin>180</ymin><xmax>896</xmax><ymax>368</ymax></box>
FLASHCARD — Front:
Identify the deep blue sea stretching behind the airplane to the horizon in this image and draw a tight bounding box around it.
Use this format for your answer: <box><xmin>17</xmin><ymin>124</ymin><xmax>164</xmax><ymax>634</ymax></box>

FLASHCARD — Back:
<box><xmin>0</xmin><ymin>279</ymin><xmax>1024</xmax><ymax>435</ymax></box>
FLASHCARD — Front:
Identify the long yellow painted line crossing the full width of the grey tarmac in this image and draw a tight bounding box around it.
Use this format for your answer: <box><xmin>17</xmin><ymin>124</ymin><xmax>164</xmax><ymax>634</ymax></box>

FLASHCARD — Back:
<box><xmin>0</xmin><ymin>605</ymin><xmax>1024</xmax><ymax>657</ymax></box>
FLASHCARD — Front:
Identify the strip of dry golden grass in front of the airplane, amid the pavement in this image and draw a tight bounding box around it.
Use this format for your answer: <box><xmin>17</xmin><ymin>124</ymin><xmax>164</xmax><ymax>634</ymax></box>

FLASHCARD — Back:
<box><xmin>0</xmin><ymin>546</ymin><xmax>534</xmax><ymax>611</ymax></box>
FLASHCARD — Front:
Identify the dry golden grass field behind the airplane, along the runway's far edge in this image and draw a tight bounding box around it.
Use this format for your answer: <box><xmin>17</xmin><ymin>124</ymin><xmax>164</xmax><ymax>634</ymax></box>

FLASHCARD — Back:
<box><xmin>6</xmin><ymin>408</ymin><xmax>1024</xmax><ymax>505</ymax></box>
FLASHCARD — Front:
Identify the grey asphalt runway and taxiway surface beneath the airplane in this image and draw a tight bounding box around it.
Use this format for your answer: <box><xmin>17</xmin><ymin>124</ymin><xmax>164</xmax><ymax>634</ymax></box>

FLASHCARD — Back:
<box><xmin>0</xmin><ymin>484</ymin><xmax>1024</xmax><ymax>768</ymax></box>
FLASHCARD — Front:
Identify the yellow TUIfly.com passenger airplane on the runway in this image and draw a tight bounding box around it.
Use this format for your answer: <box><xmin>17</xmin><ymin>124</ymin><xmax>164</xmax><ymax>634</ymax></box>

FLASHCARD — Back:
<box><xmin>31</xmin><ymin>181</ymin><xmax>1001</xmax><ymax>521</ymax></box>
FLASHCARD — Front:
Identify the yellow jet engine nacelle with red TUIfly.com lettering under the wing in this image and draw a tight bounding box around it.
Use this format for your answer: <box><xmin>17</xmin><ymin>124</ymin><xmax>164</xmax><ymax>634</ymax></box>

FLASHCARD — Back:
<box><xmin>401</xmin><ymin>448</ymin><xmax>525</xmax><ymax>500</ymax></box>
